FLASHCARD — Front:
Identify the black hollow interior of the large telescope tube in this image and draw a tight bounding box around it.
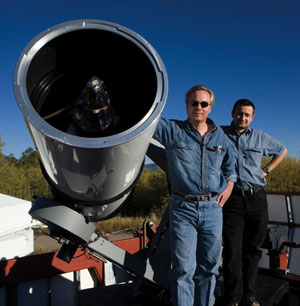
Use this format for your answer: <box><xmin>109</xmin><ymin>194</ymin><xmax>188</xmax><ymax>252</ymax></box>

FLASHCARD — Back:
<box><xmin>26</xmin><ymin>29</ymin><xmax>157</xmax><ymax>137</ymax></box>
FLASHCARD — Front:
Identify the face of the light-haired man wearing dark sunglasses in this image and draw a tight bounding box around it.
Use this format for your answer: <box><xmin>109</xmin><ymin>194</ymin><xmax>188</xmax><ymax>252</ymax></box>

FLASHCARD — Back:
<box><xmin>186</xmin><ymin>90</ymin><xmax>211</xmax><ymax>125</ymax></box>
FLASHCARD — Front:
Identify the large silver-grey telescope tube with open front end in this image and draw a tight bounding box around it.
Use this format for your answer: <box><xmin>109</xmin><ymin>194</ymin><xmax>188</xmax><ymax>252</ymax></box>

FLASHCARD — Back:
<box><xmin>14</xmin><ymin>20</ymin><xmax>168</xmax><ymax>221</ymax></box>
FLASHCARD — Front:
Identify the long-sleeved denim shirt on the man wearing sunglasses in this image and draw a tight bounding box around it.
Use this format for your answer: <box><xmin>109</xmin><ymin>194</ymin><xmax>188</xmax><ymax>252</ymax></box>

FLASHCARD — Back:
<box><xmin>153</xmin><ymin>118</ymin><xmax>236</xmax><ymax>195</ymax></box>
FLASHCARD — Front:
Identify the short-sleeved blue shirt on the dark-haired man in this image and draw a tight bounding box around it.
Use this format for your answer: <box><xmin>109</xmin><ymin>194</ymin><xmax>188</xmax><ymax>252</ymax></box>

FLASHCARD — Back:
<box><xmin>221</xmin><ymin>125</ymin><xmax>284</xmax><ymax>189</ymax></box>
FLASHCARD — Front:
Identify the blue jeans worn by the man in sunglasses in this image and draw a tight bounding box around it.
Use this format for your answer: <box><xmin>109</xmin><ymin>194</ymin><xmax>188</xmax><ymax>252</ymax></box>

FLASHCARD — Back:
<box><xmin>169</xmin><ymin>194</ymin><xmax>222</xmax><ymax>306</ymax></box>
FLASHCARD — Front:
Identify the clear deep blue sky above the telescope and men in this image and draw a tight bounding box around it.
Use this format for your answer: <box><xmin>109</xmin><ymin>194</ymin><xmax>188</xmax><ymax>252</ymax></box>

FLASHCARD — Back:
<box><xmin>0</xmin><ymin>0</ymin><xmax>300</xmax><ymax>159</ymax></box>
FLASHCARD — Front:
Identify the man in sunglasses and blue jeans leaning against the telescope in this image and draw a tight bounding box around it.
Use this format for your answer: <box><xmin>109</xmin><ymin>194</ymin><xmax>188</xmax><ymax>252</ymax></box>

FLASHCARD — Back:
<box><xmin>153</xmin><ymin>85</ymin><xmax>236</xmax><ymax>306</ymax></box>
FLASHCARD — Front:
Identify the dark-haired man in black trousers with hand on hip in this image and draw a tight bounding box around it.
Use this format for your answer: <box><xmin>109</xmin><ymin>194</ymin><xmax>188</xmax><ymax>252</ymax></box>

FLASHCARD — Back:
<box><xmin>222</xmin><ymin>99</ymin><xmax>287</xmax><ymax>306</ymax></box>
